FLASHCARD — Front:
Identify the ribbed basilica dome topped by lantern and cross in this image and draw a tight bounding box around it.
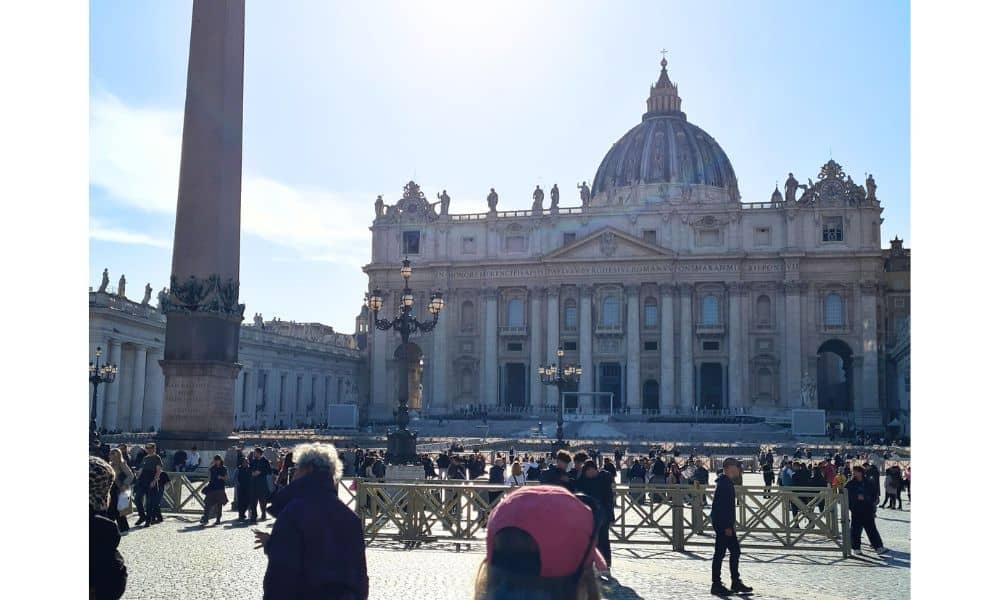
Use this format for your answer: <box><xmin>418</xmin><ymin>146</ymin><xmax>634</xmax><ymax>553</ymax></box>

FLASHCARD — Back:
<box><xmin>593</xmin><ymin>59</ymin><xmax>739</xmax><ymax>199</ymax></box>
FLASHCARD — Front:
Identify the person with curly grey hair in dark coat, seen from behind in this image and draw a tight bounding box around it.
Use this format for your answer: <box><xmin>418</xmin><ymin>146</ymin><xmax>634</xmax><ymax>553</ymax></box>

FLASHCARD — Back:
<box><xmin>254</xmin><ymin>443</ymin><xmax>368</xmax><ymax>600</ymax></box>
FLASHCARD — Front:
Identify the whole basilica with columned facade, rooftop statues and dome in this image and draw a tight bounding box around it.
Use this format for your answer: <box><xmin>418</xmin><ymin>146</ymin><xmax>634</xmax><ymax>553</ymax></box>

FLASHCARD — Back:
<box><xmin>364</xmin><ymin>60</ymin><xmax>909</xmax><ymax>429</ymax></box>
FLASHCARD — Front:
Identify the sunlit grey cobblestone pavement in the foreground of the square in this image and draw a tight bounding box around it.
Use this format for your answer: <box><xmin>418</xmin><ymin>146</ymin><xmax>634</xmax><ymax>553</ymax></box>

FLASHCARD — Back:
<box><xmin>120</xmin><ymin>476</ymin><xmax>911</xmax><ymax>600</ymax></box>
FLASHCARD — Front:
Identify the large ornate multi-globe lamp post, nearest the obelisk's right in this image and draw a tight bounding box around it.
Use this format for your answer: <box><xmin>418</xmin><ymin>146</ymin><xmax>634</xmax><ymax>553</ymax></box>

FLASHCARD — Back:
<box><xmin>365</xmin><ymin>258</ymin><xmax>444</xmax><ymax>464</ymax></box>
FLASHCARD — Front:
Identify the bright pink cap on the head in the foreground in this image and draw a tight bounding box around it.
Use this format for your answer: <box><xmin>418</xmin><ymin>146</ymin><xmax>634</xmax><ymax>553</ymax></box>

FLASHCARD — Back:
<box><xmin>486</xmin><ymin>485</ymin><xmax>608</xmax><ymax>577</ymax></box>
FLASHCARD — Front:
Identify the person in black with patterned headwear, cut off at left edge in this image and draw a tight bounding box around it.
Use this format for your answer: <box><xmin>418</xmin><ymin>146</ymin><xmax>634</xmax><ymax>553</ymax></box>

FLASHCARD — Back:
<box><xmin>88</xmin><ymin>456</ymin><xmax>128</xmax><ymax>600</ymax></box>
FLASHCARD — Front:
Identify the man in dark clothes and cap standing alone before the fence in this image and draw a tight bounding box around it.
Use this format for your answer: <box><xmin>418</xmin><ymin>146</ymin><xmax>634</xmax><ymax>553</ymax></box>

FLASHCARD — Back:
<box><xmin>712</xmin><ymin>457</ymin><xmax>753</xmax><ymax>596</ymax></box>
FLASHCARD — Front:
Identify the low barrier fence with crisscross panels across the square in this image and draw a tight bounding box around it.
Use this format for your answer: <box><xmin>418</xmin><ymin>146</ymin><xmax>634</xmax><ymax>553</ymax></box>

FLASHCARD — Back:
<box><xmin>154</xmin><ymin>473</ymin><xmax>850</xmax><ymax>557</ymax></box>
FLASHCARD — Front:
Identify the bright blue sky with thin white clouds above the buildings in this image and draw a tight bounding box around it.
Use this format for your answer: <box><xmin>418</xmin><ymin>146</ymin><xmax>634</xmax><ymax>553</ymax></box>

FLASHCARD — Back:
<box><xmin>90</xmin><ymin>0</ymin><xmax>910</xmax><ymax>331</ymax></box>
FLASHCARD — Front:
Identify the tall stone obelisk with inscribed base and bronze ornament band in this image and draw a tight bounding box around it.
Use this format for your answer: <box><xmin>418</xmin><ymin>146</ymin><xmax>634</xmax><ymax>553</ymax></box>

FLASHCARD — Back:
<box><xmin>160</xmin><ymin>0</ymin><xmax>245</xmax><ymax>440</ymax></box>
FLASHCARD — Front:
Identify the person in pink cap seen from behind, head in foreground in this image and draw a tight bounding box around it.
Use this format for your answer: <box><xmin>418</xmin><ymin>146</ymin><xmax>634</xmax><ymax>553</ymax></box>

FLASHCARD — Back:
<box><xmin>473</xmin><ymin>485</ymin><xmax>607</xmax><ymax>600</ymax></box>
